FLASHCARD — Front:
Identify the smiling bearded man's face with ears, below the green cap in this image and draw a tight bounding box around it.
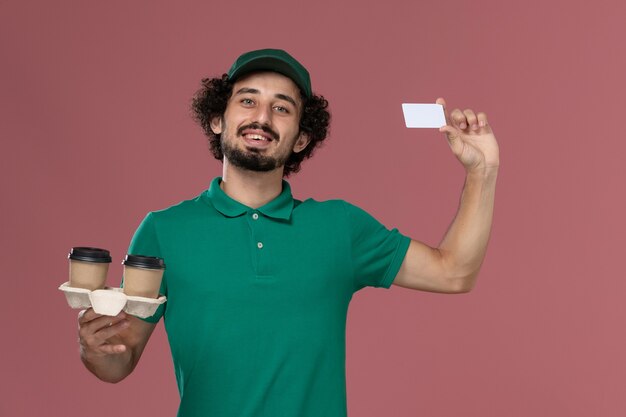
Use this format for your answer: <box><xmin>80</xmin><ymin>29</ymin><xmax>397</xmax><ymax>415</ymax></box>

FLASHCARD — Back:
<box><xmin>211</xmin><ymin>72</ymin><xmax>309</xmax><ymax>171</ymax></box>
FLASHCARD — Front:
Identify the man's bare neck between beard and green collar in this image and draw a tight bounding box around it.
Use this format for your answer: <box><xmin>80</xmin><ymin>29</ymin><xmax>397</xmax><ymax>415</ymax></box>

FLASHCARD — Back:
<box><xmin>220</xmin><ymin>159</ymin><xmax>283</xmax><ymax>209</ymax></box>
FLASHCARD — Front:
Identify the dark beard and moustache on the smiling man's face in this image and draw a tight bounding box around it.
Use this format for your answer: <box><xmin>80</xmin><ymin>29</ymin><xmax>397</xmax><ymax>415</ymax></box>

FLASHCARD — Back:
<box><xmin>220</xmin><ymin>123</ymin><xmax>291</xmax><ymax>172</ymax></box>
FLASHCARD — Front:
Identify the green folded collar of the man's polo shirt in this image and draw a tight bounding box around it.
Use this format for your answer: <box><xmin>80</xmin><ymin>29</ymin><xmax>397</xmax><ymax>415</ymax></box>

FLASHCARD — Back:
<box><xmin>204</xmin><ymin>177</ymin><xmax>293</xmax><ymax>220</ymax></box>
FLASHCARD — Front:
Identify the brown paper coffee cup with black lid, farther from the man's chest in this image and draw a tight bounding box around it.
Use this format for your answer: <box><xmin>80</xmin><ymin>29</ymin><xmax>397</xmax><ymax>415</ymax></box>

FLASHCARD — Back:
<box><xmin>68</xmin><ymin>247</ymin><xmax>111</xmax><ymax>291</ymax></box>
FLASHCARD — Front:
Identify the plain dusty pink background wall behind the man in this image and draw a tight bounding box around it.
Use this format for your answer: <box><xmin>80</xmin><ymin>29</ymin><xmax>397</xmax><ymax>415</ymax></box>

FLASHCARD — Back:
<box><xmin>0</xmin><ymin>0</ymin><xmax>626</xmax><ymax>417</ymax></box>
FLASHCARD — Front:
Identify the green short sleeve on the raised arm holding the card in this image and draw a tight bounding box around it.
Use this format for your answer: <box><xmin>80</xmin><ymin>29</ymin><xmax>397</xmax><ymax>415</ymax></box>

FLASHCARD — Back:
<box><xmin>345</xmin><ymin>203</ymin><xmax>411</xmax><ymax>291</ymax></box>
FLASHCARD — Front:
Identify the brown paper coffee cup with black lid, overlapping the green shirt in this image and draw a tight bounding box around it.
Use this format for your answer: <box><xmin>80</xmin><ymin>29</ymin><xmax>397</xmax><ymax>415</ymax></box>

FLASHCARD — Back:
<box><xmin>122</xmin><ymin>255</ymin><xmax>165</xmax><ymax>298</ymax></box>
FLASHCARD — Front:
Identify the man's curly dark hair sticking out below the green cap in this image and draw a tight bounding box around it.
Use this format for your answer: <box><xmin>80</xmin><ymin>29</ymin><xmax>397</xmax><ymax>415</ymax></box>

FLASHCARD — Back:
<box><xmin>191</xmin><ymin>74</ymin><xmax>330</xmax><ymax>177</ymax></box>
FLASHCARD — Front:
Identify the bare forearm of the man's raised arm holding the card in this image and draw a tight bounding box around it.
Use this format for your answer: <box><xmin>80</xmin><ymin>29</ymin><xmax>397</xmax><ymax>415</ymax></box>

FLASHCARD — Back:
<box><xmin>439</xmin><ymin>168</ymin><xmax>498</xmax><ymax>288</ymax></box>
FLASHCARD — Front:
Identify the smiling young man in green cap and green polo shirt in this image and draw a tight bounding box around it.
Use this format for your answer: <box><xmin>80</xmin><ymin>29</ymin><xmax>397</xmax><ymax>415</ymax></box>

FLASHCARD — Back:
<box><xmin>78</xmin><ymin>50</ymin><xmax>499</xmax><ymax>417</ymax></box>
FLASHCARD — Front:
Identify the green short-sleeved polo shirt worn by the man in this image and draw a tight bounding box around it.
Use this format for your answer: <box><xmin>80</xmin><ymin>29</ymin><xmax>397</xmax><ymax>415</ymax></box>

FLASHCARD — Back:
<box><xmin>129</xmin><ymin>178</ymin><xmax>410</xmax><ymax>417</ymax></box>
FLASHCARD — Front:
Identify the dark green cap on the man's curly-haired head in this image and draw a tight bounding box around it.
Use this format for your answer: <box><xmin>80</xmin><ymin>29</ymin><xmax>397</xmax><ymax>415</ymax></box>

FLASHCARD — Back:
<box><xmin>228</xmin><ymin>49</ymin><xmax>312</xmax><ymax>98</ymax></box>
